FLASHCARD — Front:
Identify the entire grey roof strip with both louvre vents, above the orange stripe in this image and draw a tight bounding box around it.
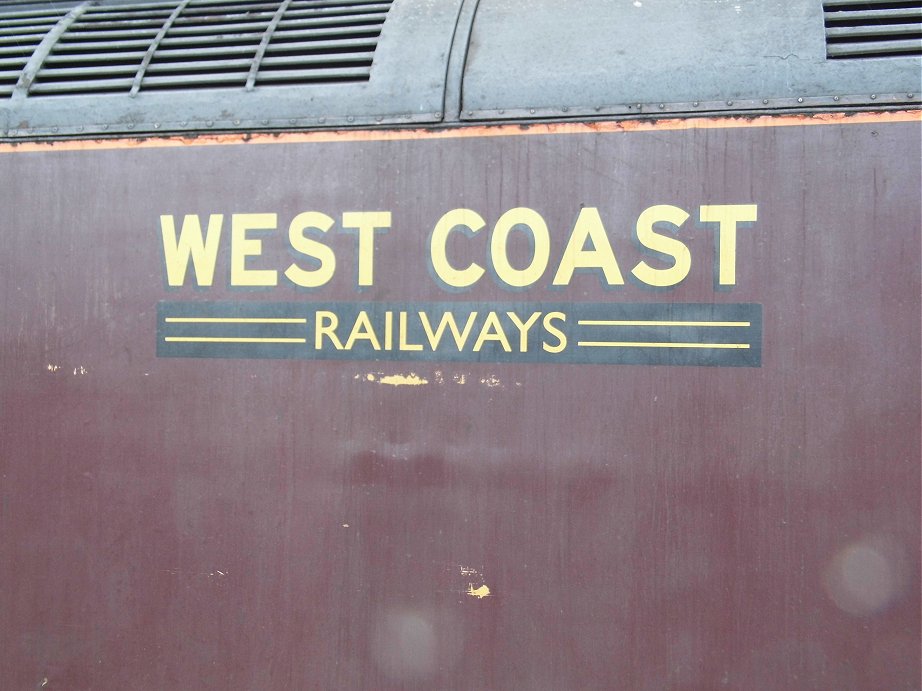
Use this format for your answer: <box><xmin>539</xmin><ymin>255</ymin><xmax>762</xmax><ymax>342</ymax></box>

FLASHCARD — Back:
<box><xmin>0</xmin><ymin>0</ymin><xmax>922</xmax><ymax>140</ymax></box>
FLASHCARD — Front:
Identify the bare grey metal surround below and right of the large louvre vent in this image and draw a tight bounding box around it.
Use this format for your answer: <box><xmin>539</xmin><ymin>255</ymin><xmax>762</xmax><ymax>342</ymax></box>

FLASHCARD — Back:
<box><xmin>0</xmin><ymin>0</ymin><xmax>461</xmax><ymax>138</ymax></box>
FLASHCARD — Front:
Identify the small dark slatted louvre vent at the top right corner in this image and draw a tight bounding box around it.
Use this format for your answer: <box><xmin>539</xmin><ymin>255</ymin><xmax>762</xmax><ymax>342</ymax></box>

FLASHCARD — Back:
<box><xmin>823</xmin><ymin>0</ymin><xmax>922</xmax><ymax>59</ymax></box>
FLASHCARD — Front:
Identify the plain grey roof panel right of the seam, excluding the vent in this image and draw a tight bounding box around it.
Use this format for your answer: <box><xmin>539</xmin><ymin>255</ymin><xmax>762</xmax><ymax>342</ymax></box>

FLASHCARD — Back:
<box><xmin>462</xmin><ymin>0</ymin><xmax>922</xmax><ymax>120</ymax></box>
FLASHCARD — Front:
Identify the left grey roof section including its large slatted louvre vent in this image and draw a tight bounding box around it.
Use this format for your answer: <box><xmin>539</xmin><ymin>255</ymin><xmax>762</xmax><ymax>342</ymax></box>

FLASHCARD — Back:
<box><xmin>0</xmin><ymin>0</ymin><xmax>461</xmax><ymax>138</ymax></box>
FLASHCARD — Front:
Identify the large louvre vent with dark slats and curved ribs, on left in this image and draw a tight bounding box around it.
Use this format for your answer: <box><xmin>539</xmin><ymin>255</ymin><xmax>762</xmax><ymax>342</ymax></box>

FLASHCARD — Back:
<box><xmin>0</xmin><ymin>0</ymin><xmax>392</xmax><ymax>97</ymax></box>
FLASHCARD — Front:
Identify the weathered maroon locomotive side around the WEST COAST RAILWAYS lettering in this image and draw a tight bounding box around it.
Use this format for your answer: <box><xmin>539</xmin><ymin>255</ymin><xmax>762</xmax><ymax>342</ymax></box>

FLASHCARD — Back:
<box><xmin>0</xmin><ymin>114</ymin><xmax>920</xmax><ymax>689</ymax></box>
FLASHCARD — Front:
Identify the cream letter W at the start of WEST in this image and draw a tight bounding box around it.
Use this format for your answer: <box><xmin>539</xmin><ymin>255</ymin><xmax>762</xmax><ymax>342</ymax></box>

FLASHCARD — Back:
<box><xmin>160</xmin><ymin>214</ymin><xmax>224</xmax><ymax>286</ymax></box>
